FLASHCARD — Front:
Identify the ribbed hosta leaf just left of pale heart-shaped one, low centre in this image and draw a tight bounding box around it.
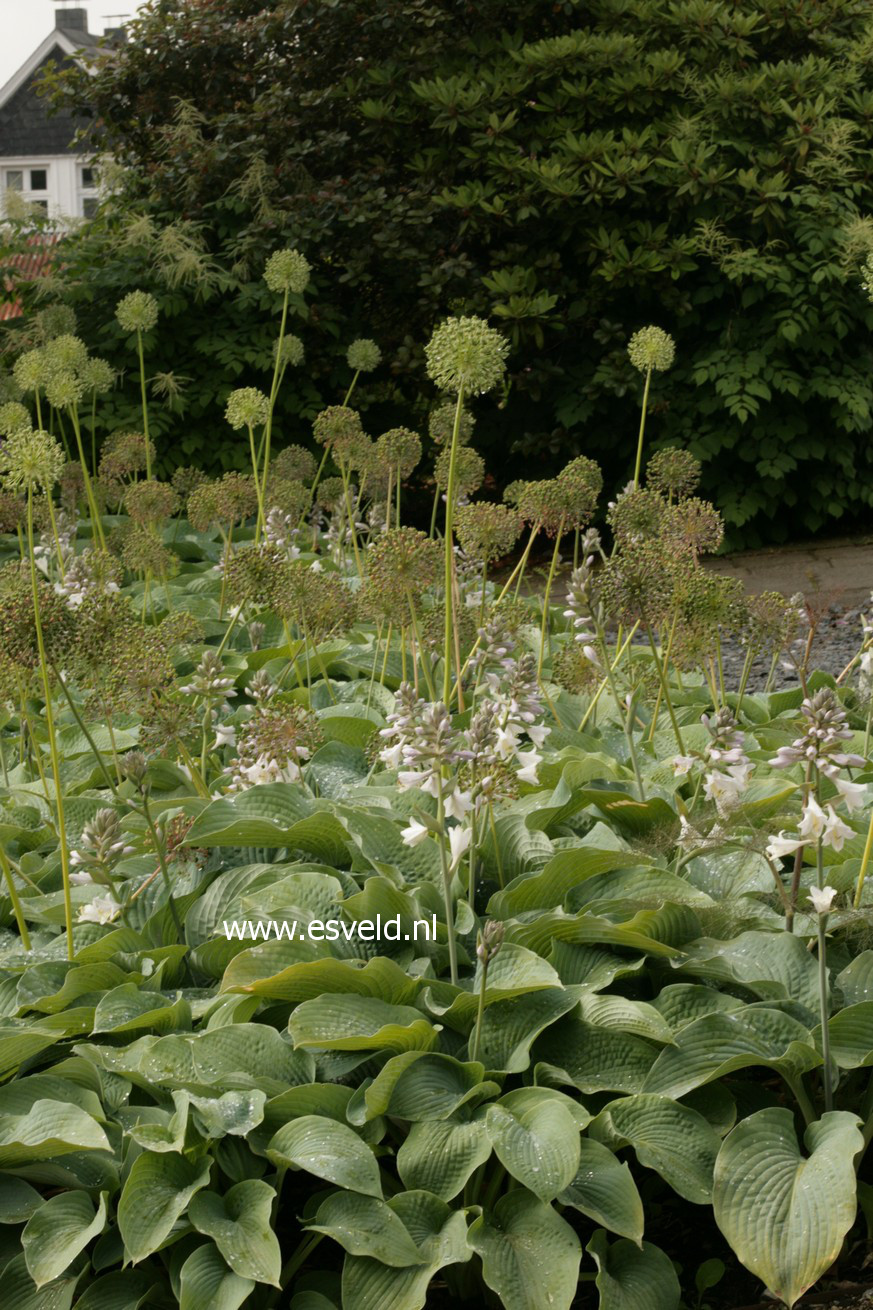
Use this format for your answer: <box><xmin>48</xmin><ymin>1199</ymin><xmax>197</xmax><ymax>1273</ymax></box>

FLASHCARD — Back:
<box><xmin>397</xmin><ymin>1110</ymin><xmax>492</xmax><ymax>1201</ymax></box>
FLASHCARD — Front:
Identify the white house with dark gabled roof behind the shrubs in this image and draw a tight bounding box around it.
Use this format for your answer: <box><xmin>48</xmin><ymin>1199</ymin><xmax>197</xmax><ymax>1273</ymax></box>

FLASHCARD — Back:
<box><xmin>0</xmin><ymin>0</ymin><xmax>123</xmax><ymax>220</ymax></box>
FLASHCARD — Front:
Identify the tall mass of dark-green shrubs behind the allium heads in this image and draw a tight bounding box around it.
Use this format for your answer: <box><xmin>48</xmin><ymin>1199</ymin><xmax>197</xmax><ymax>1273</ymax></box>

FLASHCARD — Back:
<box><xmin>32</xmin><ymin>0</ymin><xmax>873</xmax><ymax>544</ymax></box>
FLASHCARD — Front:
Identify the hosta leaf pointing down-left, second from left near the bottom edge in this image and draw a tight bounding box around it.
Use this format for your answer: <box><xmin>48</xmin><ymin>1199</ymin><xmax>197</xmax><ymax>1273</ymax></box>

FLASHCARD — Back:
<box><xmin>118</xmin><ymin>1151</ymin><xmax>211</xmax><ymax>1264</ymax></box>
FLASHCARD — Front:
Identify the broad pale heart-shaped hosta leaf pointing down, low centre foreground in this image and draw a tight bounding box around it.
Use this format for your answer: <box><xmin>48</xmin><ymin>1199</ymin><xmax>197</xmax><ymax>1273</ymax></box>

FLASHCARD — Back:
<box><xmin>485</xmin><ymin>1087</ymin><xmax>579</xmax><ymax>1201</ymax></box>
